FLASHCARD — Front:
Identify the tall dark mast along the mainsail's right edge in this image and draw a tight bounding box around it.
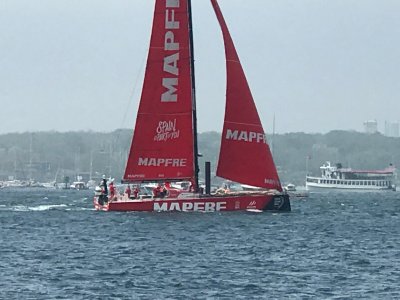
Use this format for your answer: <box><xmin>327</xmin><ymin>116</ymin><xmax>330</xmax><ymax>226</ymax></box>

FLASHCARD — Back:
<box><xmin>187</xmin><ymin>0</ymin><xmax>199</xmax><ymax>191</ymax></box>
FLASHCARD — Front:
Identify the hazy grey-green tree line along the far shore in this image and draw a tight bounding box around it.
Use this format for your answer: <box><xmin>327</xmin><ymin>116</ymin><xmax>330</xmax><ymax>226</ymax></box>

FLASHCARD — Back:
<box><xmin>0</xmin><ymin>129</ymin><xmax>400</xmax><ymax>185</ymax></box>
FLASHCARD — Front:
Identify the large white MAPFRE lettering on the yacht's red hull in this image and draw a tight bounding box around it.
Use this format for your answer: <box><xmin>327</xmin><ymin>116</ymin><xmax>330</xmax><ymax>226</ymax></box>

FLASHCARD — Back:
<box><xmin>153</xmin><ymin>201</ymin><xmax>226</xmax><ymax>211</ymax></box>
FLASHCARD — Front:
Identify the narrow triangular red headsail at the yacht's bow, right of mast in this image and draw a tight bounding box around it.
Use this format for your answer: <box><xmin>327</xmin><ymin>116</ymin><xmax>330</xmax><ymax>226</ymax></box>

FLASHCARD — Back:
<box><xmin>211</xmin><ymin>0</ymin><xmax>282</xmax><ymax>190</ymax></box>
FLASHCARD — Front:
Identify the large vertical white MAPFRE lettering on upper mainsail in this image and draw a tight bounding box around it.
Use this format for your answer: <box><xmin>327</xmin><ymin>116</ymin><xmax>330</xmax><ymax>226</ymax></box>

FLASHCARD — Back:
<box><xmin>161</xmin><ymin>0</ymin><xmax>180</xmax><ymax>102</ymax></box>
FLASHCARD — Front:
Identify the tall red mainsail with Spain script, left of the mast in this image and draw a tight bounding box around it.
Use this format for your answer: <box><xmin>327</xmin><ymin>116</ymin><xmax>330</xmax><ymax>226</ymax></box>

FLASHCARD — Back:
<box><xmin>124</xmin><ymin>0</ymin><xmax>194</xmax><ymax>182</ymax></box>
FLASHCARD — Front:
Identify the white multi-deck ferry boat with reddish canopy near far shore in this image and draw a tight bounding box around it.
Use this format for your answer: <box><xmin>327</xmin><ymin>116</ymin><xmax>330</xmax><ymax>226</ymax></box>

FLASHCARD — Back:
<box><xmin>306</xmin><ymin>161</ymin><xmax>396</xmax><ymax>191</ymax></box>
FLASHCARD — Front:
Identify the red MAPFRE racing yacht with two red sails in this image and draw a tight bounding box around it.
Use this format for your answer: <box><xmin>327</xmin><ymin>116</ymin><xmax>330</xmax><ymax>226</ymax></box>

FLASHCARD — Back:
<box><xmin>94</xmin><ymin>0</ymin><xmax>291</xmax><ymax>211</ymax></box>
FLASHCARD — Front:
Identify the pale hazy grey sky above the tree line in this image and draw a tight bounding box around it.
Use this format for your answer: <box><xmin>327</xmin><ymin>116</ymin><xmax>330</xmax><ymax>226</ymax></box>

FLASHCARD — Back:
<box><xmin>0</xmin><ymin>0</ymin><xmax>400</xmax><ymax>133</ymax></box>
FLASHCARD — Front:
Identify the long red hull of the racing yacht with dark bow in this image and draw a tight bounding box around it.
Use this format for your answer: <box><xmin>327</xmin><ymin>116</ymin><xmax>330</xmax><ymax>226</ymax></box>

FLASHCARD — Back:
<box><xmin>94</xmin><ymin>193</ymin><xmax>290</xmax><ymax>212</ymax></box>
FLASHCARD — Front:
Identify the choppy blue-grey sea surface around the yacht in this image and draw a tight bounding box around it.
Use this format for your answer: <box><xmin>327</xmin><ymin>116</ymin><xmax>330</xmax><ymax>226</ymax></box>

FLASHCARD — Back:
<box><xmin>0</xmin><ymin>188</ymin><xmax>400</xmax><ymax>299</ymax></box>
